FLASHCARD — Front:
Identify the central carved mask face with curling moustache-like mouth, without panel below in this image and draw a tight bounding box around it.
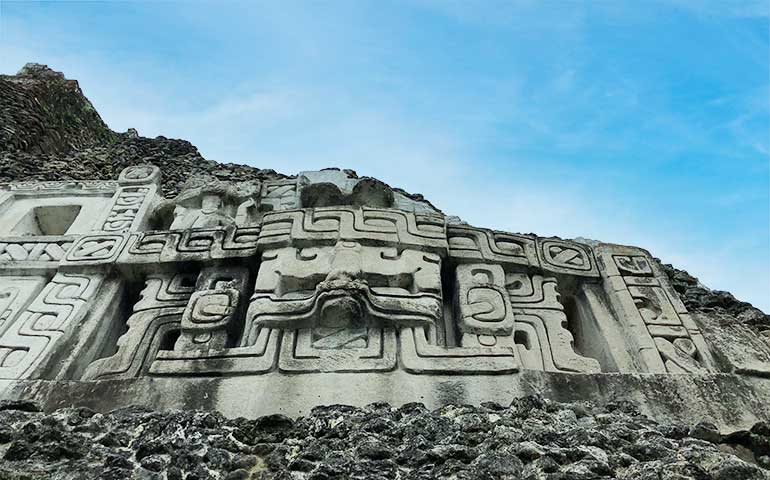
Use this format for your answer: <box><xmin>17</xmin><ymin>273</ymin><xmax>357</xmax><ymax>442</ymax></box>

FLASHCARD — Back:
<box><xmin>247</xmin><ymin>241</ymin><xmax>441</xmax><ymax>338</ymax></box>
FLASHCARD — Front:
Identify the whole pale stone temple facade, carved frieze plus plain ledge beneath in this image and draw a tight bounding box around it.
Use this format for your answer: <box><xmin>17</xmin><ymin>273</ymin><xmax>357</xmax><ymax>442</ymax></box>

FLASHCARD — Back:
<box><xmin>0</xmin><ymin>164</ymin><xmax>770</xmax><ymax>430</ymax></box>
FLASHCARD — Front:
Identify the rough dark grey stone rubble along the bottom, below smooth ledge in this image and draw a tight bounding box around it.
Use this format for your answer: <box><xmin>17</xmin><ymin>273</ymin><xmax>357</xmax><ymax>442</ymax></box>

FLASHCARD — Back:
<box><xmin>0</xmin><ymin>396</ymin><xmax>770</xmax><ymax>480</ymax></box>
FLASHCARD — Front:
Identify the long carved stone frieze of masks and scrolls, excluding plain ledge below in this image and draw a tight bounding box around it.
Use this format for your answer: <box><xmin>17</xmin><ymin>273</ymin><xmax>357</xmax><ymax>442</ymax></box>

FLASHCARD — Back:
<box><xmin>0</xmin><ymin>165</ymin><xmax>736</xmax><ymax>381</ymax></box>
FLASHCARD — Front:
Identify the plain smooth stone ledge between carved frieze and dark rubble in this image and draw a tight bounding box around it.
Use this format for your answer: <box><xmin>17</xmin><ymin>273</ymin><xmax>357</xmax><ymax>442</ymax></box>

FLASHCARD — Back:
<box><xmin>0</xmin><ymin>371</ymin><xmax>770</xmax><ymax>431</ymax></box>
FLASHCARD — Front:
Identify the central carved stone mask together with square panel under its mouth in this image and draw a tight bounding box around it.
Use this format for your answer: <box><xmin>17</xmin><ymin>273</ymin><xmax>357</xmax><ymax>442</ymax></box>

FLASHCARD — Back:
<box><xmin>243</xmin><ymin>240</ymin><xmax>441</xmax><ymax>371</ymax></box>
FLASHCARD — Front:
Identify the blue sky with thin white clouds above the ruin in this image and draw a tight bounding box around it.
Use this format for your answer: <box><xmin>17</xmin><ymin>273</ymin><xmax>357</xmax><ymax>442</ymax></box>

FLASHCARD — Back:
<box><xmin>0</xmin><ymin>0</ymin><xmax>770</xmax><ymax>311</ymax></box>
